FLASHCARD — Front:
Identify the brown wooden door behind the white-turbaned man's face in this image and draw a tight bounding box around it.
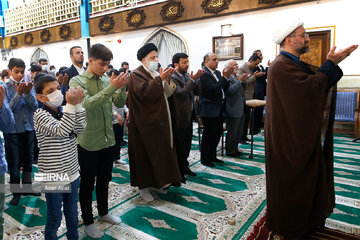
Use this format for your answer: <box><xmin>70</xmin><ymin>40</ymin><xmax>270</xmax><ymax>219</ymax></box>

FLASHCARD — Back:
<box><xmin>300</xmin><ymin>31</ymin><xmax>331</xmax><ymax>67</ymax></box>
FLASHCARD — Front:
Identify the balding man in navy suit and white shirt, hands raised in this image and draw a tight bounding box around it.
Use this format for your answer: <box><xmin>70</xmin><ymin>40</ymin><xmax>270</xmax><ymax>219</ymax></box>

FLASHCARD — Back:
<box><xmin>199</xmin><ymin>53</ymin><xmax>233</xmax><ymax>167</ymax></box>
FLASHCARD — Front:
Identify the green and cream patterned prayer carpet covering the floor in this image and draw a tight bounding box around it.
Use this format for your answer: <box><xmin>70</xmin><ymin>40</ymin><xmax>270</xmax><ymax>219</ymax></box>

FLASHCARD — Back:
<box><xmin>0</xmin><ymin>127</ymin><xmax>360</xmax><ymax>240</ymax></box>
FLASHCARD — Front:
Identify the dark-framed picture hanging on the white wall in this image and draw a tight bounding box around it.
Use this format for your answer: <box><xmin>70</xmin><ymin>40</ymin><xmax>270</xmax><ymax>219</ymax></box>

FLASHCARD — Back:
<box><xmin>213</xmin><ymin>34</ymin><xmax>244</xmax><ymax>61</ymax></box>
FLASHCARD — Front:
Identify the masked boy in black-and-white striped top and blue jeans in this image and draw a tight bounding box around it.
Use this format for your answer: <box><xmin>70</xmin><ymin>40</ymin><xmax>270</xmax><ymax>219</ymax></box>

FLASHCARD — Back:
<box><xmin>34</xmin><ymin>75</ymin><xmax>86</xmax><ymax>239</ymax></box>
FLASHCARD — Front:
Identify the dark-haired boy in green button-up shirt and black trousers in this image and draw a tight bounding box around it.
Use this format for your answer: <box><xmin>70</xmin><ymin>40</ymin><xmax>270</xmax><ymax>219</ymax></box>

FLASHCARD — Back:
<box><xmin>70</xmin><ymin>44</ymin><xmax>129</xmax><ymax>238</ymax></box>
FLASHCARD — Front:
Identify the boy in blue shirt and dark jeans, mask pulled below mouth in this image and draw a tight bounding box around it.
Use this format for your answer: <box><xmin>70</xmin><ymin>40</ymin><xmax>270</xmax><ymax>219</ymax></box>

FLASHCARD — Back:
<box><xmin>4</xmin><ymin>58</ymin><xmax>40</xmax><ymax>205</ymax></box>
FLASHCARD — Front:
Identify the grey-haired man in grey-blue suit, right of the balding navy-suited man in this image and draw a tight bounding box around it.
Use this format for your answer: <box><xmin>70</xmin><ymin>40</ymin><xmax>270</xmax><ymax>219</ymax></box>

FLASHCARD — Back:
<box><xmin>225</xmin><ymin>59</ymin><xmax>250</xmax><ymax>157</ymax></box>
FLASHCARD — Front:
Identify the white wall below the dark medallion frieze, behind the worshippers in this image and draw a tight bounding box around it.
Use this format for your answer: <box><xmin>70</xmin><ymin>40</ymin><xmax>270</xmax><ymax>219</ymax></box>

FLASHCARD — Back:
<box><xmin>0</xmin><ymin>0</ymin><xmax>360</xmax><ymax>86</ymax></box>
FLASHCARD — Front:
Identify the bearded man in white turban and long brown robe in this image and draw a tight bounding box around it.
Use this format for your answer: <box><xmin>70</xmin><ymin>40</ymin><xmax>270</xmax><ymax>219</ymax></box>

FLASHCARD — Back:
<box><xmin>265</xmin><ymin>21</ymin><xmax>357</xmax><ymax>238</ymax></box>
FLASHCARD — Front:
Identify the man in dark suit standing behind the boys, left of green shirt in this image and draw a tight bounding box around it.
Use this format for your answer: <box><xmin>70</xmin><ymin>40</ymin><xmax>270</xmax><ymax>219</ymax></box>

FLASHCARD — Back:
<box><xmin>58</xmin><ymin>46</ymin><xmax>86</xmax><ymax>101</ymax></box>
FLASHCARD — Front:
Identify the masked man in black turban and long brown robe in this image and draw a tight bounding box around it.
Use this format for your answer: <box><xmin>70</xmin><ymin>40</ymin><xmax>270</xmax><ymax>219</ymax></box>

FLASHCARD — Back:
<box><xmin>129</xmin><ymin>43</ymin><xmax>181</xmax><ymax>202</ymax></box>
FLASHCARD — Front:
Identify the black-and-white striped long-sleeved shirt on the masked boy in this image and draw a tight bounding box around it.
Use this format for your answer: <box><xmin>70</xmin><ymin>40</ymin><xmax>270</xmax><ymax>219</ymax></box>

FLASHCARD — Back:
<box><xmin>34</xmin><ymin>103</ymin><xmax>86</xmax><ymax>182</ymax></box>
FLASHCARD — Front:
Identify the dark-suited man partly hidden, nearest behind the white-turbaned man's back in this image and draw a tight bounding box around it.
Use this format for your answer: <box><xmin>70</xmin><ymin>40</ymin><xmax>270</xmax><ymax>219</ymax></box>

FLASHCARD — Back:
<box><xmin>253</xmin><ymin>50</ymin><xmax>271</xmax><ymax>134</ymax></box>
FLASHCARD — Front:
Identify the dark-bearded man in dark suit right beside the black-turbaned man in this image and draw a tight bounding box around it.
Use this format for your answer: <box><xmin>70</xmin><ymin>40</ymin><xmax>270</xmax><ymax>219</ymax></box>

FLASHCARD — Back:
<box><xmin>169</xmin><ymin>53</ymin><xmax>205</xmax><ymax>180</ymax></box>
